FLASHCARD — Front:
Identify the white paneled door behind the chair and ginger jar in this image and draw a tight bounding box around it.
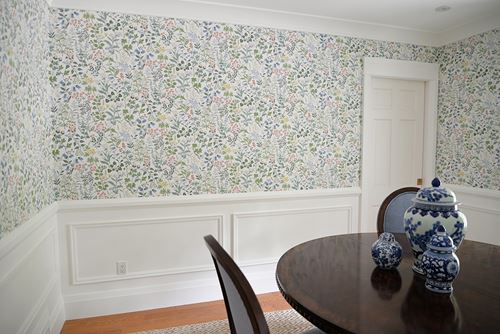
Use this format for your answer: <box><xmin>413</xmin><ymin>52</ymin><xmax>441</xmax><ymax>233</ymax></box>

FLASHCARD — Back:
<box><xmin>362</xmin><ymin>78</ymin><xmax>425</xmax><ymax>232</ymax></box>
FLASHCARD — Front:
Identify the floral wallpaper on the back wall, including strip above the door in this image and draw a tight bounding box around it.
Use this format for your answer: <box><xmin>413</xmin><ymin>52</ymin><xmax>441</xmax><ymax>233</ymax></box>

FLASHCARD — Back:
<box><xmin>50</xmin><ymin>9</ymin><xmax>436</xmax><ymax>199</ymax></box>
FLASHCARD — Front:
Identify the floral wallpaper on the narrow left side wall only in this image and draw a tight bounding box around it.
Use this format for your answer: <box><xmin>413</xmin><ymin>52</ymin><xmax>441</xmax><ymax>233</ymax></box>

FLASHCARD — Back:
<box><xmin>0</xmin><ymin>0</ymin><xmax>54</xmax><ymax>238</ymax></box>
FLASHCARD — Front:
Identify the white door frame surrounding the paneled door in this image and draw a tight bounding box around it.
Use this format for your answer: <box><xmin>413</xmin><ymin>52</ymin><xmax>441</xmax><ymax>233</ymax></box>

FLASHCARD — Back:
<box><xmin>359</xmin><ymin>57</ymin><xmax>439</xmax><ymax>232</ymax></box>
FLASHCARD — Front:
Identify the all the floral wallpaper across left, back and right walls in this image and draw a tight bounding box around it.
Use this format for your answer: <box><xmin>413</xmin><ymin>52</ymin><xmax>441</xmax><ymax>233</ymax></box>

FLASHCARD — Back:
<box><xmin>0</xmin><ymin>4</ymin><xmax>500</xmax><ymax>238</ymax></box>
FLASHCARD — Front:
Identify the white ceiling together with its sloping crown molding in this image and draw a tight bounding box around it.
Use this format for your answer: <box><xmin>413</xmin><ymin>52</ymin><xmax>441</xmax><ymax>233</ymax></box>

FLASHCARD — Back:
<box><xmin>47</xmin><ymin>0</ymin><xmax>500</xmax><ymax>46</ymax></box>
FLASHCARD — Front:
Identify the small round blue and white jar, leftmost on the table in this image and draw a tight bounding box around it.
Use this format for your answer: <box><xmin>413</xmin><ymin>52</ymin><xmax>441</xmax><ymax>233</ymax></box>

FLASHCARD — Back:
<box><xmin>372</xmin><ymin>232</ymin><xmax>403</xmax><ymax>269</ymax></box>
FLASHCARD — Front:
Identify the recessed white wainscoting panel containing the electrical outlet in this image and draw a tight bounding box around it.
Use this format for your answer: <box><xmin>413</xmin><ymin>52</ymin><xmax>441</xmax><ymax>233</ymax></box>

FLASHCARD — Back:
<box><xmin>68</xmin><ymin>215</ymin><xmax>222</xmax><ymax>284</ymax></box>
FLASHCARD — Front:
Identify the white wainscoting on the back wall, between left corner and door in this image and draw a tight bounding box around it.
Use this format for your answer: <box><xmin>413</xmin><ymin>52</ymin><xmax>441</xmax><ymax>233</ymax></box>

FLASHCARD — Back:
<box><xmin>58</xmin><ymin>188</ymin><xmax>360</xmax><ymax>319</ymax></box>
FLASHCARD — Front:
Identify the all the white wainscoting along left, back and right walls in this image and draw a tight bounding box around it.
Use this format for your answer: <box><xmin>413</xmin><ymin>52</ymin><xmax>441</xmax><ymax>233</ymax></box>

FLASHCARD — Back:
<box><xmin>0</xmin><ymin>185</ymin><xmax>500</xmax><ymax>324</ymax></box>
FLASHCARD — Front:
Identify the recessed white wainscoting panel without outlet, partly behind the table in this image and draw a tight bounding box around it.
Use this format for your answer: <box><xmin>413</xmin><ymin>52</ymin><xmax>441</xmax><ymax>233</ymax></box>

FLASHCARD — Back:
<box><xmin>233</xmin><ymin>206</ymin><xmax>353</xmax><ymax>266</ymax></box>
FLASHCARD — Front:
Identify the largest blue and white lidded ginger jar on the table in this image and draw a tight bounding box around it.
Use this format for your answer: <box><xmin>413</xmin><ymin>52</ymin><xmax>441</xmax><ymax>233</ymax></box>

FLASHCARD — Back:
<box><xmin>404</xmin><ymin>178</ymin><xmax>467</xmax><ymax>275</ymax></box>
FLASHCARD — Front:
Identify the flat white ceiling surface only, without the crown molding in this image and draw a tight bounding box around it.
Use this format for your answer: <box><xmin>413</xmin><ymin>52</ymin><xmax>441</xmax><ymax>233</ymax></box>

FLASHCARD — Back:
<box><xmin>183</xmin><ymin>0</ymin><xmax>500</xmax><ymax>32</ymax></box>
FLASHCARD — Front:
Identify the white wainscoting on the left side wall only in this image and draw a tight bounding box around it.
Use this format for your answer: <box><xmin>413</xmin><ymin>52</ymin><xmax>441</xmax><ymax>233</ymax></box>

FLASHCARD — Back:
<box><xmin>0</xmin><ymin>203</ymin><xmax>65</xmax><ymax>334</ymax></box>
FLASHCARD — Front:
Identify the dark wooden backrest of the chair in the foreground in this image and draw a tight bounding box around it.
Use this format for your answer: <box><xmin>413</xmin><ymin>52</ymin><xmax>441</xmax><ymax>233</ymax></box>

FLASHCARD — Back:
<box><xmin>204</xmin><ymin>235</ymin><xmax>269</xmax><ymax>334</ymax></box>
